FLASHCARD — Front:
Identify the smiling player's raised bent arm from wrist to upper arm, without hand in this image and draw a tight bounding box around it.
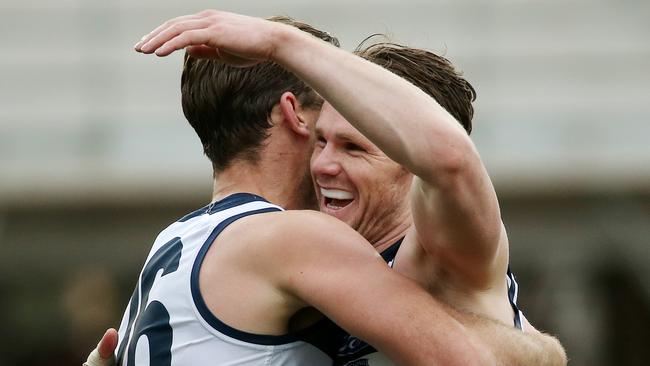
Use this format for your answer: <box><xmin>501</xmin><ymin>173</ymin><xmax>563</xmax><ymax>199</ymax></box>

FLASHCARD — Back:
<box><xmin>273</xmin><ymin>27</ymin><xmax>508</xmax><ymax>288</ymax></box>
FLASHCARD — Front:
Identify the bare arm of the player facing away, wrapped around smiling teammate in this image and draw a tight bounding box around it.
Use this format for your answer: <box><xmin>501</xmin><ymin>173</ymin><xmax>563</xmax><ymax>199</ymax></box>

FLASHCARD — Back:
<box><xmin>258</xmin><ymin>211</ymin><xmax>494</xmax><ymax>366</ymax></box>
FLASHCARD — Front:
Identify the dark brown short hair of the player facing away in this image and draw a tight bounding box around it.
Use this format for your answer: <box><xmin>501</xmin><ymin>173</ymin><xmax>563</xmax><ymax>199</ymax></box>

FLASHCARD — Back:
<box><xmin>181</xmin><ymin>16</ymin><xmax>339</xmax><ymax>173</ymax></box>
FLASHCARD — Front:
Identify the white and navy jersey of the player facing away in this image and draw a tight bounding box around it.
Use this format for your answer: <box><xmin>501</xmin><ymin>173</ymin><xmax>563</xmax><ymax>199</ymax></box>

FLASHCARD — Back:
<box><xmin>117</xmin><ymin>193</ymin><xmax>332</xmax><ymax>366</ymax></box>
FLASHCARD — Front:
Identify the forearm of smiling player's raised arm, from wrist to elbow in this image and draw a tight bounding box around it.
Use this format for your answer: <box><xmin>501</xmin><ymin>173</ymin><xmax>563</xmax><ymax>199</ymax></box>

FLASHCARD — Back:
<box><xmin>273</xmin><ymin>29</ymin><xmax>472</xmax><ymax>176</ymax></box>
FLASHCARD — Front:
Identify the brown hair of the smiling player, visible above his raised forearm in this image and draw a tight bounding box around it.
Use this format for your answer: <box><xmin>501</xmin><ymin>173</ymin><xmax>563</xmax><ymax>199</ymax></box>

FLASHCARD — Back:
<box><xmin>355</xmin><ymin>42</ymin><xmax>476</xmax><ymax>134</ymax></box>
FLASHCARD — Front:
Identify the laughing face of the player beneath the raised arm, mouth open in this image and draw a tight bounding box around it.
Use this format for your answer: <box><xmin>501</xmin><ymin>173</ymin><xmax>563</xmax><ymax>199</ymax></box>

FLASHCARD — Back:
<box><xmin>311</xmin><ymin>103</ymin><xmax>412</xmax><ymax>243</ymax></box>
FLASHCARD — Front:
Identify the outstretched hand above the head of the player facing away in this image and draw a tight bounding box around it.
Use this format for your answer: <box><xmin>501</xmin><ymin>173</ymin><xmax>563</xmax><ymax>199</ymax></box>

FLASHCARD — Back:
<box><xmin>134</xmin><ymin>10</ymin><xmax>284</xmax><ymax>66</ymax></box>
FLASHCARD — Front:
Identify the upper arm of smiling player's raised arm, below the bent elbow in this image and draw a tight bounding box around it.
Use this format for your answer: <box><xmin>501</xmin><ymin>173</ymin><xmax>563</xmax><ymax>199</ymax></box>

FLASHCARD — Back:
<box><xmin>411</xmin><ymin>156</ymin><xmax>508</xmax><ymax>287</ymax></box>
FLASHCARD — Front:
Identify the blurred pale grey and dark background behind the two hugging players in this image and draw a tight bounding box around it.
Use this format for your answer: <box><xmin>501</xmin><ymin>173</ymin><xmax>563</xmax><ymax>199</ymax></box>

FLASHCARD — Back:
<box><xmin>0</xmin><ymin>0</ymin><xmax>650</xmax><ymax>366</ymax></box>
